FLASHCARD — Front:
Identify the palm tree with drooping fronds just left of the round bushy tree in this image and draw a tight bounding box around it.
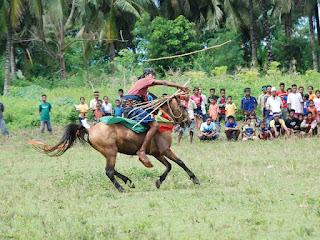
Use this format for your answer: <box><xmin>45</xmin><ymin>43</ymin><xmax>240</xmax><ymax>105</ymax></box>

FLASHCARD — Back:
<box><xmin>77</xmin><ymin>0</ymin><xmax>157</xmax><ymax>74</ymax></box>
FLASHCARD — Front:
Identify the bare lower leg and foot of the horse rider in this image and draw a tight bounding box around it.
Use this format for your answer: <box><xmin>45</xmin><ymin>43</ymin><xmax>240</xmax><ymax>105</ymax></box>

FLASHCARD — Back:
<box><xmin>137</xmin><ymin>122</ymin><xmax>159</xmax><ymax>168</ymax></box>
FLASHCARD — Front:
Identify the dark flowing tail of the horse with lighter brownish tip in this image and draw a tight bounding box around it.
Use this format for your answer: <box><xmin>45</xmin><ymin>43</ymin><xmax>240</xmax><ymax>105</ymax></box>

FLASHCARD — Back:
<box><xmin>29</xmin><ymin>123</ymin><xmax>90</xmax><ymax>157</ymax></box>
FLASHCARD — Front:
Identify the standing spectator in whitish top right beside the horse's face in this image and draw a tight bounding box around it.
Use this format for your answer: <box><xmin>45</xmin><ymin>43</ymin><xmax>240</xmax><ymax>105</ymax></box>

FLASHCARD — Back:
<box><xmin>178</xmin><ymin>94</ymin><xmax>197</xmax><ymax>145</ymax></box>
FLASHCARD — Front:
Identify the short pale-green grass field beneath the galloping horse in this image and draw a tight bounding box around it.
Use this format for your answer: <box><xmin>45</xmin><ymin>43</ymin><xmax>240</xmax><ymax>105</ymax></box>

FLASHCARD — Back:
<box><xmin>0</xmin><ymin>129</ymin><xmax>320</xmax><ymax>239</ymax></box>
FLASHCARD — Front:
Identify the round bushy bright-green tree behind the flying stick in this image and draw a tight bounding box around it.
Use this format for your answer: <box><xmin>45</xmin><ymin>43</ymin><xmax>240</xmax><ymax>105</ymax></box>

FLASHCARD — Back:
<box><xmin>133</xmin><ymin>14</ymin><xmax>201</xmax><ymax>70</ymax></box>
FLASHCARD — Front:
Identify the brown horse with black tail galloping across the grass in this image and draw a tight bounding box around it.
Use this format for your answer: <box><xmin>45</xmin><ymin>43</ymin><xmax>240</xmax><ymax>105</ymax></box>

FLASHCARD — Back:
<box><xmin>32</xmin><ymin>98</ymin><xmax>200</xmax><ymax>192</ymax></box>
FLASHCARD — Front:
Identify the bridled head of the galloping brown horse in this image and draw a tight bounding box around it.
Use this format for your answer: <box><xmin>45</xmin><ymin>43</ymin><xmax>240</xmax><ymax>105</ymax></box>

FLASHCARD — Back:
<box><xmin>163</xmin><ymin>96</ymin><xmax>189</xmax><ymax>124</ymax></box>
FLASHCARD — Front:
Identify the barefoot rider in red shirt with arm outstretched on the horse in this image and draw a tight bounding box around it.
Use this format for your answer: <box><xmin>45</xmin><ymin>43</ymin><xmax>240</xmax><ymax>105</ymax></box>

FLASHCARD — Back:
<box><xmin>124</xmin><ymin>68</ymin><xmax>190</xmax><ymax>168</ymax></box>
